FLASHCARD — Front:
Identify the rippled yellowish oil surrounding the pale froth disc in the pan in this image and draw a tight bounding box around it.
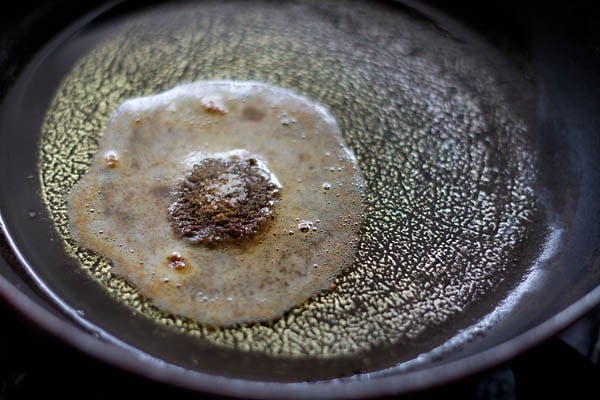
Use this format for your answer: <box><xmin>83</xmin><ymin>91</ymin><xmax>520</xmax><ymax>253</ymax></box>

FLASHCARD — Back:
<box><xmin>39</xmin><ymin>1</ymin><xmax>539</xmax><ymax>369</ymax></box>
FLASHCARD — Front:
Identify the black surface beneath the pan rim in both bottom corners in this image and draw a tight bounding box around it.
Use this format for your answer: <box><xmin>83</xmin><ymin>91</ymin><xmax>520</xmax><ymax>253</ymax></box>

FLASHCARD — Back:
<box><xmin>0</xmin><ymin>302</ymin><xmax>600</xmax><ymax>400</ymax></box>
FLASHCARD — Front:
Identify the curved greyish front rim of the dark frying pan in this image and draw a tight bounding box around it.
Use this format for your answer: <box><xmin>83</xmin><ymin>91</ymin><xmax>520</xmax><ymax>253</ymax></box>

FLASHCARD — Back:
<box><xmin>0</xmin><ymin>219</ymin><xmax>600</xmax><ymax>399</ymax></box>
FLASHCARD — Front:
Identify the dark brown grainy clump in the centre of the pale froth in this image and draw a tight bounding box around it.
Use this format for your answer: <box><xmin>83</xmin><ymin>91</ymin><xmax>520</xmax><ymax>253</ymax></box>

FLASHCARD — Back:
<box><xmin>169</xmin><ymin>156</ymin><xmax>279</xmax><ymax>244</ymax></box>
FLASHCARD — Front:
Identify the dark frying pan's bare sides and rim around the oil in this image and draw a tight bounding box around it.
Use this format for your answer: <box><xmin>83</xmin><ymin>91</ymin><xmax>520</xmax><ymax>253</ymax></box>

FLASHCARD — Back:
<box><xmin>0</xmin><ymin>2</ymin><xmax>600</xmax><ymax>398</ymax></box>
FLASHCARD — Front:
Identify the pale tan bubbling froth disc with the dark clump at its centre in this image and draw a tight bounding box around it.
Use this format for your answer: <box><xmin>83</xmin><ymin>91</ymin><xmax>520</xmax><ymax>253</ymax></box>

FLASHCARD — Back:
<box><xmin>68</xmin><ymin>81</ymin><xmax>364</xmax><ymax>326</ymax></box>
